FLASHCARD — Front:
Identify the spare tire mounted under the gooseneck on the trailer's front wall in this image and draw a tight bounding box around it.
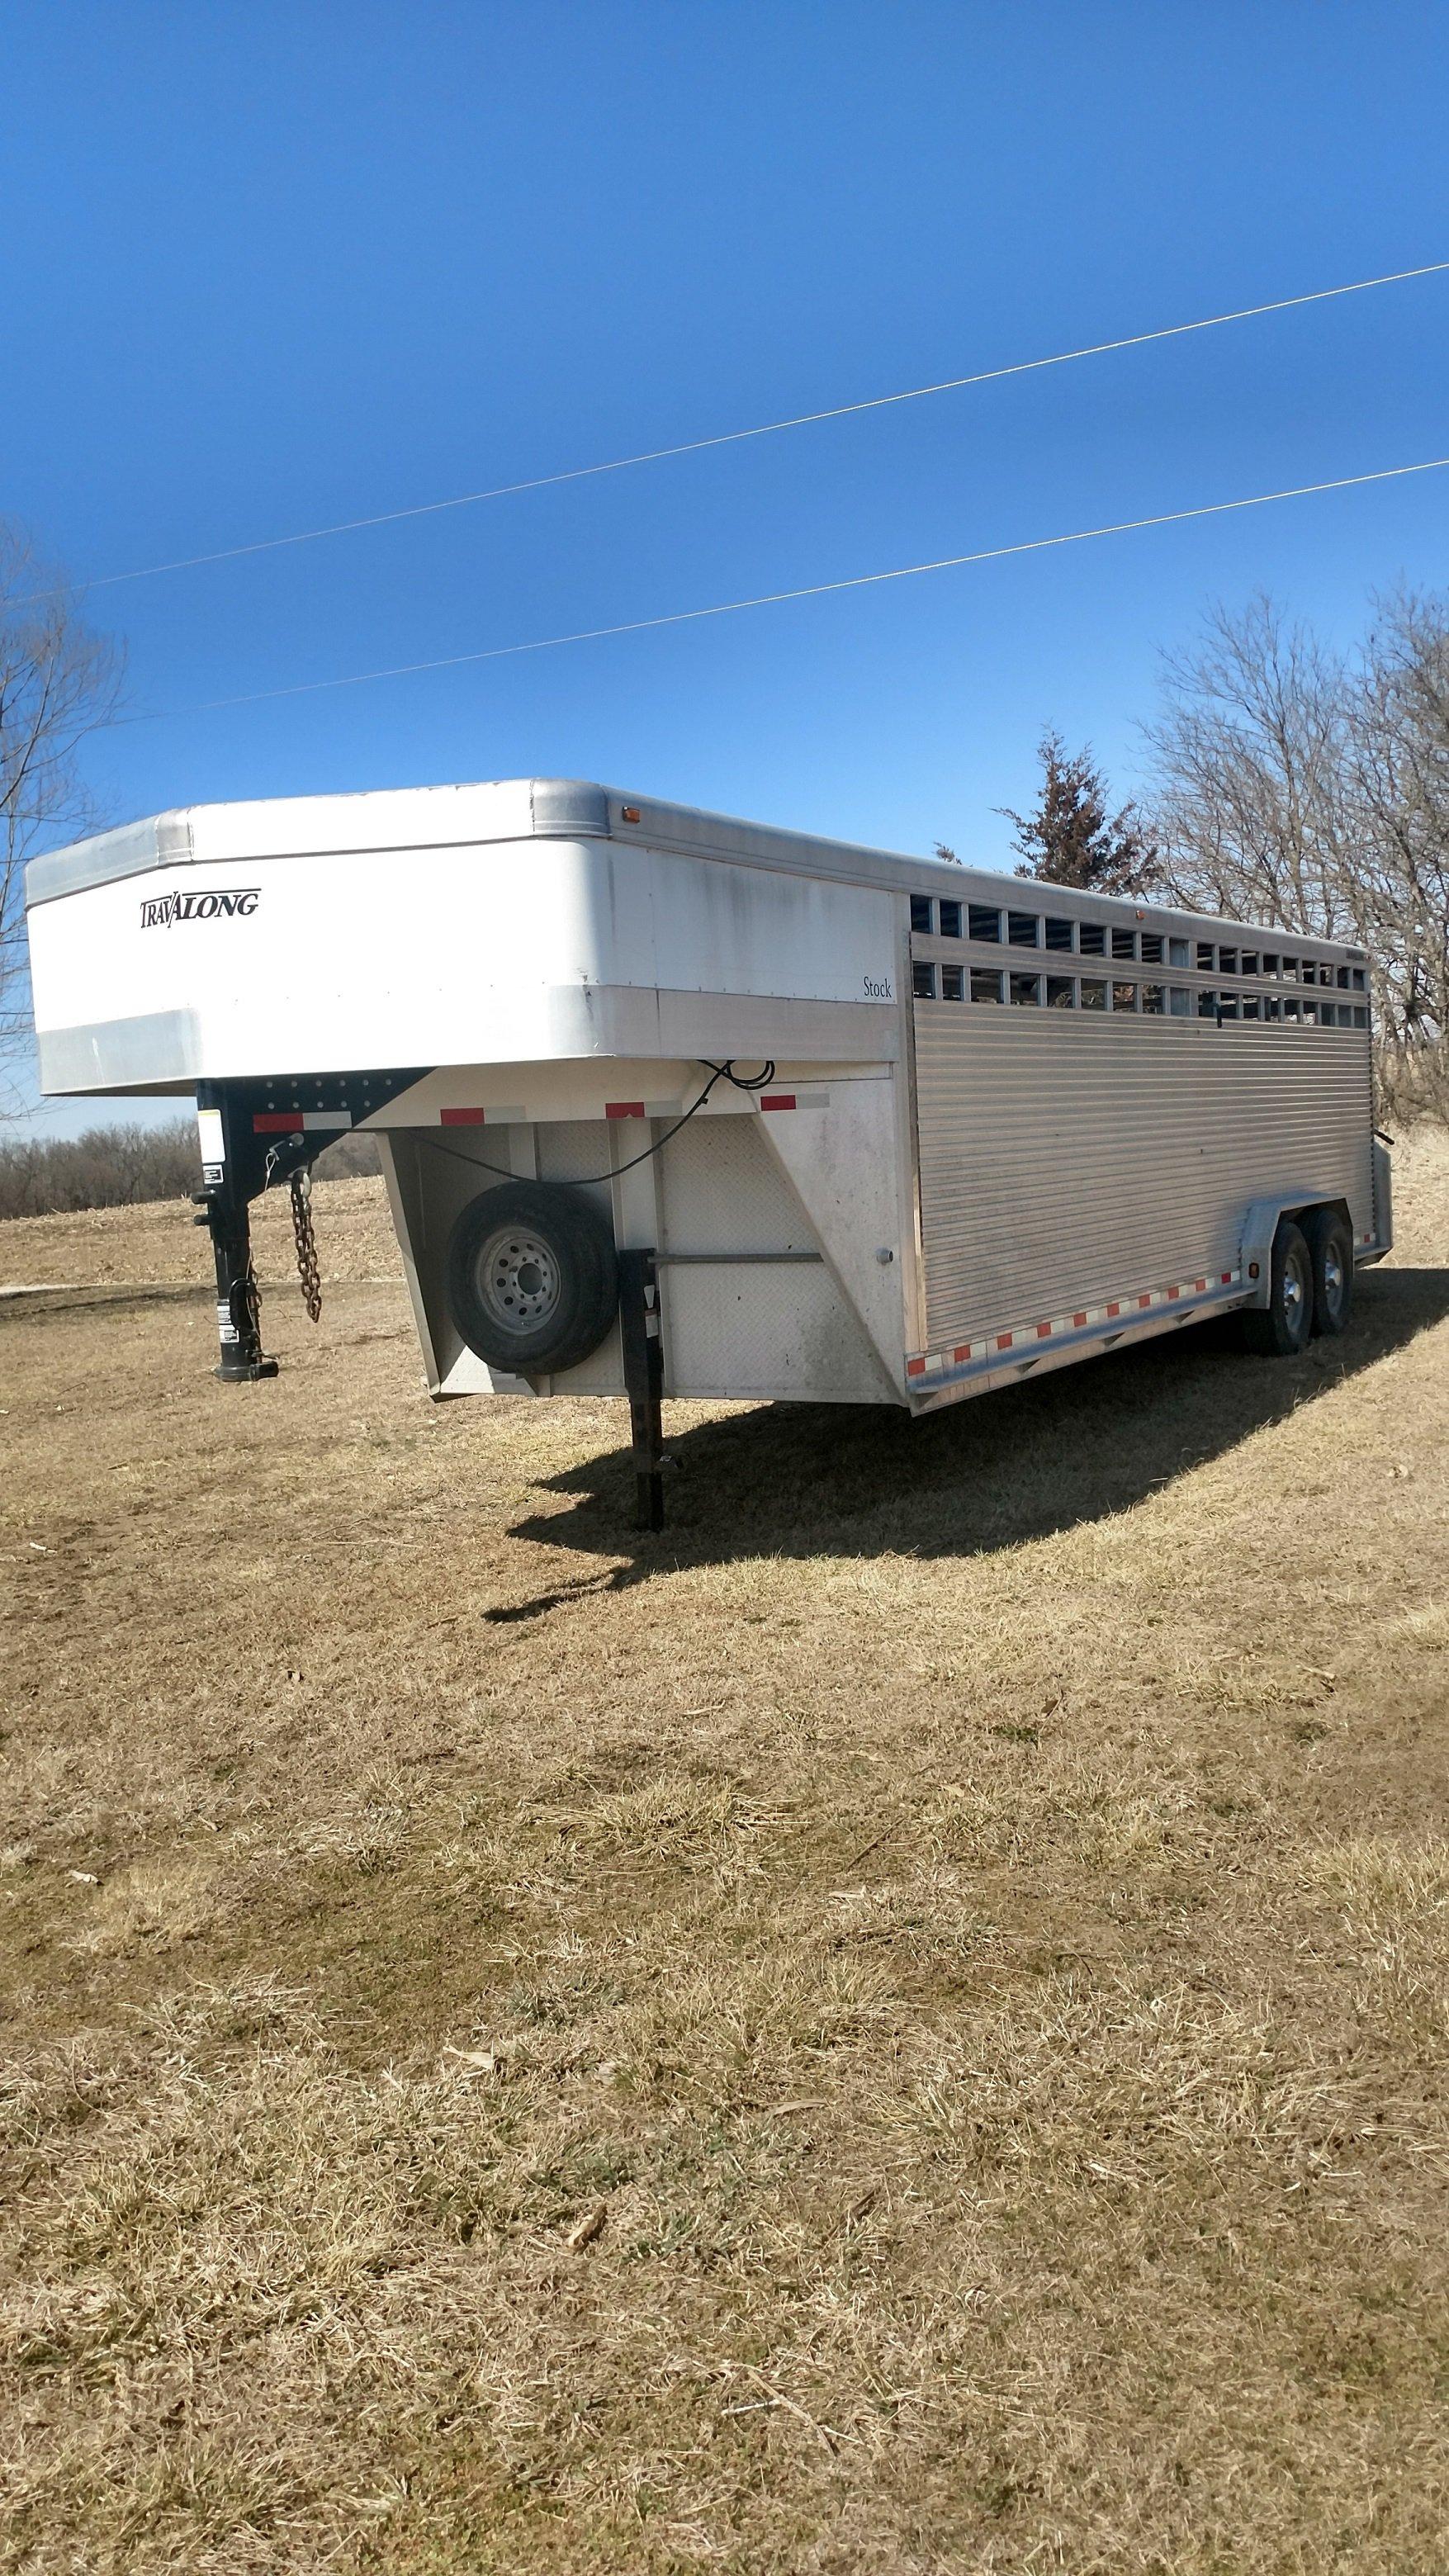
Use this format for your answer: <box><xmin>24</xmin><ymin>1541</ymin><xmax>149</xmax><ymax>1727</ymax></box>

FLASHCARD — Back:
<box><xmin>446</xmin><ymin>1180</ymin><xmax>618</xmax><ymax>1378</ymax></box>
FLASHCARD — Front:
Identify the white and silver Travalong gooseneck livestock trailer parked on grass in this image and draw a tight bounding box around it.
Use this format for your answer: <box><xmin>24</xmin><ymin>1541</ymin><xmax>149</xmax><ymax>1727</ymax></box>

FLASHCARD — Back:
<box><xmin>26</xmin><ymin>778</ymin><xmax>1390</xmax><ymax>1520</ymax></box>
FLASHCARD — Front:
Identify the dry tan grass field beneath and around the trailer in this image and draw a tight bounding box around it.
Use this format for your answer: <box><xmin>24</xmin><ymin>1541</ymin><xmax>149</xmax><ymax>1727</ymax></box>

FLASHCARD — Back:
<box><xmin>0</xmin><ymin>1136</ymin><xmax>1449</xmax><ymax>2576</ymax></box>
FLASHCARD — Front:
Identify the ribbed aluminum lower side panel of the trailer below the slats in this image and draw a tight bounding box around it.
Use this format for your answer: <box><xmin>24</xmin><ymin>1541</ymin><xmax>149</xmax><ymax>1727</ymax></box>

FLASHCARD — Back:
<box><xmin>916</xmin><ymin>1002</ymin><xmax>1374</xmax><ymax>1347</ymax></box>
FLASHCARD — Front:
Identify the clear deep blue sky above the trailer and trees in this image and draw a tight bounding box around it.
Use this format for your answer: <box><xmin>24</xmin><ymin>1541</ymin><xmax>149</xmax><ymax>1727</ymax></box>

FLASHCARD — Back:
<box><xmin>0</xmin><ymin>0</ymin><xmax>1449</xmax><ymax>1125</ymax></box>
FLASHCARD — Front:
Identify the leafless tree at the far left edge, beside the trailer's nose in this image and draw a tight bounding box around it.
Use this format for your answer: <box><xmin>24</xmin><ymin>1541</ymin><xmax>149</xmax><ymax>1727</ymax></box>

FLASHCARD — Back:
<box><xmin>0</xmin><ymin>523</ymin><xmax>121</xmax><ymax>1102</ymax></box>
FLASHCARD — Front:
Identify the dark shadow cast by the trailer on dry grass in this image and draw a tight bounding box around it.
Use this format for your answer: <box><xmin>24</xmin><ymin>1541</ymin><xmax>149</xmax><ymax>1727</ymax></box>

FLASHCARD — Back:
<box><xmin>487</xmin><ymin>1267</ymin><xmax>1449</xmax><ymax>1623</ymax></box>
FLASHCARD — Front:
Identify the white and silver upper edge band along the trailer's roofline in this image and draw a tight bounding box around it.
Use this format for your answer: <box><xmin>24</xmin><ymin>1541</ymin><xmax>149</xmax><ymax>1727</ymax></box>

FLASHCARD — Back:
<box><xmin>26</xmin><ymin>778</ymin><xmax>1364</xmax><ymax>959</ymax></box>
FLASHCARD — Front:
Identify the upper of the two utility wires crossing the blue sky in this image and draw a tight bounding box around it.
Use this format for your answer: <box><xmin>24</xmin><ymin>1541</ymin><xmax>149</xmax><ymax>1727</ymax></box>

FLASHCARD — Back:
<box><xmin>31</xmin><ymin>260</ymin><xmax>1449</xmax><ymax>598</ymax></box>
